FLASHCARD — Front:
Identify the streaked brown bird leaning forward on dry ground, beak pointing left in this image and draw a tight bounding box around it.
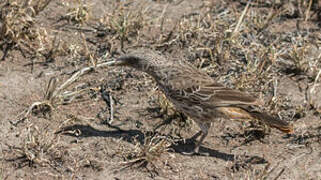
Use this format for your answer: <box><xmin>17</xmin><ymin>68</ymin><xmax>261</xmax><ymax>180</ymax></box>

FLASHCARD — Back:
<box><xmin>114</xmin><ymin>48</ymin><xmax>294</xmax><ymax>154</ymax></box>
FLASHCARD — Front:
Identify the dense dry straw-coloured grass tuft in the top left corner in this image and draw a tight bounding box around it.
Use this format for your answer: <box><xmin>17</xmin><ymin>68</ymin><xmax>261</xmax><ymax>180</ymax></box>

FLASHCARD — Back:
<box><xmin>0</xmin><ymin>0</ymin><xmax>51</xmax><ymax>60</ymax></box>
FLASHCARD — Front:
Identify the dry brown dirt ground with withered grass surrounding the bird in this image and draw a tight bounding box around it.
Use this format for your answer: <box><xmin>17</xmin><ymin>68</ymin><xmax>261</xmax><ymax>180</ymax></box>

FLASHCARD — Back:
<box><xmin>0</xmin><ymin>0</ymin><xmax>321</xmax><ymax>180</ymax></box>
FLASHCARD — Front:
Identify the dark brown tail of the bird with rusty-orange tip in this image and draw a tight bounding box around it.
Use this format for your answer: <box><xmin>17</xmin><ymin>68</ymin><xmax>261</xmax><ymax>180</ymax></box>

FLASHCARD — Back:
<box><xmin>250</xmin><ymin>112</ymin><xmax>294</xmax><ymax>134</ymax></box>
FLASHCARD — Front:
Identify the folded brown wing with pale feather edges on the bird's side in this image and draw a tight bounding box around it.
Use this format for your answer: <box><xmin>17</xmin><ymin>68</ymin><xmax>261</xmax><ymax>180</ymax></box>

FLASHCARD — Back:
<box><xmin>169</xmin><ymin>69</ymin><xmax>260</xmax><ymax>106</ymax></box>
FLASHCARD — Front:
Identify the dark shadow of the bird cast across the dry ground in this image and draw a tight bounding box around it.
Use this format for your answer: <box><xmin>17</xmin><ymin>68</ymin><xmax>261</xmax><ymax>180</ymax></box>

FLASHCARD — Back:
<box><xmin>56</xmin><ymin>124</ymin><xmax>267</xmax><ymax>164</ymax></box>
